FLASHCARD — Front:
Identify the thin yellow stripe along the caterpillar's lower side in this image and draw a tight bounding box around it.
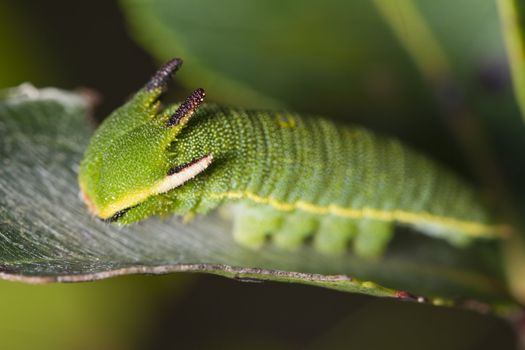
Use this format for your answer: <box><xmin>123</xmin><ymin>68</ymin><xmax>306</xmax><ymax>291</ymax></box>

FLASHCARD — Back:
<box><xmin>210</xmin><ymin>192</ymin><xmax>510</xmax><ymax>238</ymax></box>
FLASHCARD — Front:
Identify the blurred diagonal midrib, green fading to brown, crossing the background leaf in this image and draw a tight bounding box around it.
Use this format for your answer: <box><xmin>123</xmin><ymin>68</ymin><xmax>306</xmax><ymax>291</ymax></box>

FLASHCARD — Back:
<box><xmin>373</xmin><ymin>0</ymin><xmax>511</xmax><ymax>214</ymax></box>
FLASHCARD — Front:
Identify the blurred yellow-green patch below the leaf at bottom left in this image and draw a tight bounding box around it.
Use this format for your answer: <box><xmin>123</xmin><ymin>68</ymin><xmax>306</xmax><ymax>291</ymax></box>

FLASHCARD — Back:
<box><xmin>0</xmin><ymin>276</ymin><xmax>191</xmax><ymax>350</ymax></box>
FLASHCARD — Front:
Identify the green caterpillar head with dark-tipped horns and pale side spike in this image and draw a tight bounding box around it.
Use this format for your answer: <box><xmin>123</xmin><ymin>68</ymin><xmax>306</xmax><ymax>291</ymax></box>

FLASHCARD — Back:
<box><xmin>79</xmin><ymin>58</ymin><xmax>213</xmax><ymax>222</ymax></box>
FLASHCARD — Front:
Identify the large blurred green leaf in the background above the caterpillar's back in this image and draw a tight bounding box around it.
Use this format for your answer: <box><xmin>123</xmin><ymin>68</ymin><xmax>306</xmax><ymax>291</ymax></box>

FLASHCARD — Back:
<box><xmin>116</xmin><ymin>0</ymin><xmax>504</xmax><ymax>124</ymax></box>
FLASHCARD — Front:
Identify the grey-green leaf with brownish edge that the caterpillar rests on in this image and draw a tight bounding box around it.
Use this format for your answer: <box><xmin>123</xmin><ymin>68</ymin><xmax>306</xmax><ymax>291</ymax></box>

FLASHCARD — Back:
<box><xmin>0</xmin><ymin>85</ymin><xmax>512</xmax><ymax>312</ymax></box>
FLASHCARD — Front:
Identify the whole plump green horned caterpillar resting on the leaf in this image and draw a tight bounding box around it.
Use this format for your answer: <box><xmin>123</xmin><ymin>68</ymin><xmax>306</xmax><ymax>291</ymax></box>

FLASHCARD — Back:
<box><xmin>79</xmin><ymin>59</ymin><xmax>503</xmax><ymax>257</ymax></box>
